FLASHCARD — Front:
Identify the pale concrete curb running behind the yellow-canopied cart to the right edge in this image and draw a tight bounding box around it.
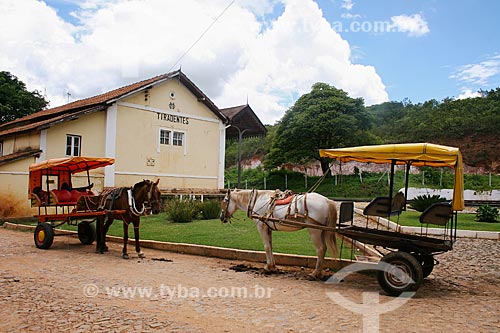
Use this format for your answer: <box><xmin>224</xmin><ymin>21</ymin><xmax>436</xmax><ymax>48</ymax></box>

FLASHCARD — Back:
<box><xmin>354</xmin><ymin>208</ymin><xmax>500</xmax><ymax>240</ymax></box>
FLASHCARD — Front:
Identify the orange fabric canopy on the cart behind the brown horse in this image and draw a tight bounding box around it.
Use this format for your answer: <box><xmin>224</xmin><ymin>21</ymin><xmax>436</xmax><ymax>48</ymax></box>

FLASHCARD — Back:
<box><xmin>30</xmin><ymin>156</ymin><xmax>115</xmax><ymax>174</ymax></box>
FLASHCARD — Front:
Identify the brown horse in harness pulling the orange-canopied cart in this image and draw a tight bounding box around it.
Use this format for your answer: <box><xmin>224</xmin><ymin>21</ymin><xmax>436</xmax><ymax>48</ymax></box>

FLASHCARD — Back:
<box><xmin>96</xmin><ymin>179</ymin><xmax>160</xmax><ymax>259</ymax></box>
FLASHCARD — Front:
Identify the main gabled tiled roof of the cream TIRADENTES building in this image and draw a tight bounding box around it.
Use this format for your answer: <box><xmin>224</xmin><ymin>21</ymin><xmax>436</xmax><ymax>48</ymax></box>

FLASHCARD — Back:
<box><xmin>0</xmin><ymin>70</ymin><xmax>227</xmax><ymax>137</ymax></box>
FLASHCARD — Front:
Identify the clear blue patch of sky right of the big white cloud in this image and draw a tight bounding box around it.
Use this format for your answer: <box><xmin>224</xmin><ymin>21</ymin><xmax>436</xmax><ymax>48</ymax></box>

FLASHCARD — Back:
<box><xmin>319</xmin><ymin>0</ymin><xmax>500</xmax><ymax>102</ymax></box>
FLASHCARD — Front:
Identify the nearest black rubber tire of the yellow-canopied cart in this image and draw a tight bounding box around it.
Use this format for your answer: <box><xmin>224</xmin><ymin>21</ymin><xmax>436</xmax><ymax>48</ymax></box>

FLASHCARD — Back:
<box><xmin>377</xmin><ymin>251</ymin><xmax>424</xmax><ymax>296</ymax></box>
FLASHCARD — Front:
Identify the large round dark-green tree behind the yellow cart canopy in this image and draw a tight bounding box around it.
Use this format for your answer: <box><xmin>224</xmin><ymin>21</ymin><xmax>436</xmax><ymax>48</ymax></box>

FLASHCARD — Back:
<box><xmin>265</xmin><ymin>83</ymin><xmax>376</xmax><ymax>172</ymax></box>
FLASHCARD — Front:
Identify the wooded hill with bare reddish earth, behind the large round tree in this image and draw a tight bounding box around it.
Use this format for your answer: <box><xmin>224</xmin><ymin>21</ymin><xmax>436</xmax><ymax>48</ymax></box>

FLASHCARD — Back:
<box><xmin>226</xmin><ymin>88</ymin><xmax>500</xmax><ymax>173</ymax></box>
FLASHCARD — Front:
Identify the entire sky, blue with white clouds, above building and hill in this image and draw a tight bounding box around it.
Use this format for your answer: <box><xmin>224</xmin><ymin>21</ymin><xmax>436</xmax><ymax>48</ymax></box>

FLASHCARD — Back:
<box><xmin>0</xmin><ymin>0</ymin><xmax>500</xmax><ymax>124</ymax></box>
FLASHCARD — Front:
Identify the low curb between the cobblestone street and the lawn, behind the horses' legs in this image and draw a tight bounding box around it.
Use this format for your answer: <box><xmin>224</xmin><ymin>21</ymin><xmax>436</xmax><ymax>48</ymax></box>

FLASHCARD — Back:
<box><xmin>3</xmin><ymin>222</ymin><xmax>352</xmax><ymax>270</ymax></box>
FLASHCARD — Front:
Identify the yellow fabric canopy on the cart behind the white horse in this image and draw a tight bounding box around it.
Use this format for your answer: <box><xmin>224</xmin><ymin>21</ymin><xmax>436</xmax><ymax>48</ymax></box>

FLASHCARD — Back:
<box><xmin>319</xmin><ymin>143</ymin><xmax>465</xmax><ymax>210</ymax></box>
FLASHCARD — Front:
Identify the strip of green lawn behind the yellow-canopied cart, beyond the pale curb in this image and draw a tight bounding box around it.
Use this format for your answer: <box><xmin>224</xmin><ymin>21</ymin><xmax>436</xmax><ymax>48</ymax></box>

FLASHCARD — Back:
<box><xmin>391</xmin><ymin>210</ymin><xmax>500</xmax><ymax>232</ymax></box>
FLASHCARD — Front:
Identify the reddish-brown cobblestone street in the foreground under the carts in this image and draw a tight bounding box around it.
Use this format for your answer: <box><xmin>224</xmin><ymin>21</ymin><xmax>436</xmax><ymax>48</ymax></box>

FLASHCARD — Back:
<box><xmin>0</xmin><ymin>224</ymin><xmax>500</xmax><ymax>333</ymax></box>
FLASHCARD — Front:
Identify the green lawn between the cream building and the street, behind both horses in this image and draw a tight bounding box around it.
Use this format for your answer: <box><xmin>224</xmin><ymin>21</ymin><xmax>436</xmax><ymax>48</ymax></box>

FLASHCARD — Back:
<box><xmin>61</xmin><ymin>211</ymin><xmax>351</xmax><ymax>258</ymax></box>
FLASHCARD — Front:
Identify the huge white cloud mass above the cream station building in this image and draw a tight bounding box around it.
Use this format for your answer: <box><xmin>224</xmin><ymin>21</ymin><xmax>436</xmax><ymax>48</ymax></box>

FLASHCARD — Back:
<box><xmin>0</xmin><ymin>0</ymin><xmax>388</xmax><ymax>123</ymax></box>
